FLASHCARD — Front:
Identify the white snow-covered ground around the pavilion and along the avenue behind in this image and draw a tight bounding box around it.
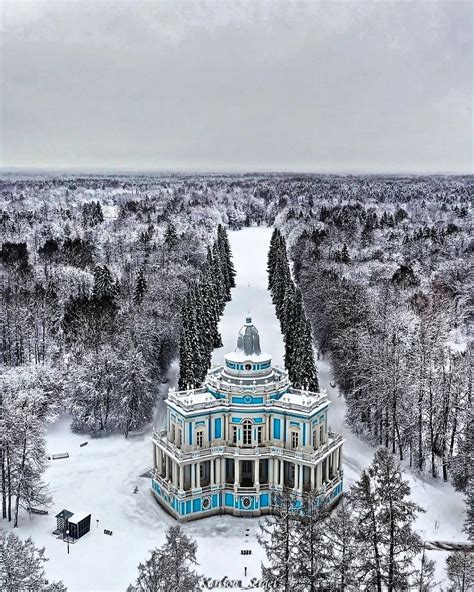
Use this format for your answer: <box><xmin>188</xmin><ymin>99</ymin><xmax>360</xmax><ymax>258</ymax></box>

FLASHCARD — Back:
<box><xmin>7</xmin><ymin>228</ymin><xmax>464</xmax><ymax>592</ymax></box>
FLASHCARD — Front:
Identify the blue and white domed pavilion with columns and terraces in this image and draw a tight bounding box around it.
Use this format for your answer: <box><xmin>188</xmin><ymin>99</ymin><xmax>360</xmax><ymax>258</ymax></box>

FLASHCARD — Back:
<box><xmin>152</xmin><ymin>318</ymin><xmax>343</xmax><ymax>521</ymax></box>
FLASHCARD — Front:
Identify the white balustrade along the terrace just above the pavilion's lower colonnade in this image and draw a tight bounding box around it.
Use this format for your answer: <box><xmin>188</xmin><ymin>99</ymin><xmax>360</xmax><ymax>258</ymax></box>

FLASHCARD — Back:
<box><xmin>153</xmin><ymin>430</ymin><xmax>344</xmax><ymax>463</ymax></box>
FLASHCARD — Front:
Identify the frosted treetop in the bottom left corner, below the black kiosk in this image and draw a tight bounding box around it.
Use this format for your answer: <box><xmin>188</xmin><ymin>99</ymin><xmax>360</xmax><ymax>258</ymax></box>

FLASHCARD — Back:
<box><xmin>0</xmin><ymin>529</ymin><xmax>66</xmax><ymax>592</ymax></box>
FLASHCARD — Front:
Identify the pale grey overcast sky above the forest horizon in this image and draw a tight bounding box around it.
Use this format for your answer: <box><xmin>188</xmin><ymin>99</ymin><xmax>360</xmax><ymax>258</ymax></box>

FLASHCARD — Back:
<box><xmin>0</xmin><ymin>0</ymin><xmax>474</xmax><ymax>172</ymax></box>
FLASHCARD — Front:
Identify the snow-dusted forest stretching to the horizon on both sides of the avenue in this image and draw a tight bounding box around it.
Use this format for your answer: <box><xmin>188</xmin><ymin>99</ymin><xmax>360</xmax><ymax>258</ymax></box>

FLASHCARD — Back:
<box><xmin>0</xmin><ymin>174</ymin><xmax>474</xmax><ymax>512</ymax></box>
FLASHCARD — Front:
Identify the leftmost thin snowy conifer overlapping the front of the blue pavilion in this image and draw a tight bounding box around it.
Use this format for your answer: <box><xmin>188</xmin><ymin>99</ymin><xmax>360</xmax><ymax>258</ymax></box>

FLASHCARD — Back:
<box><xmin>258</xmin><ymin>490</ymin><xmax>300</xmax><ymax>592</ymax></box>
